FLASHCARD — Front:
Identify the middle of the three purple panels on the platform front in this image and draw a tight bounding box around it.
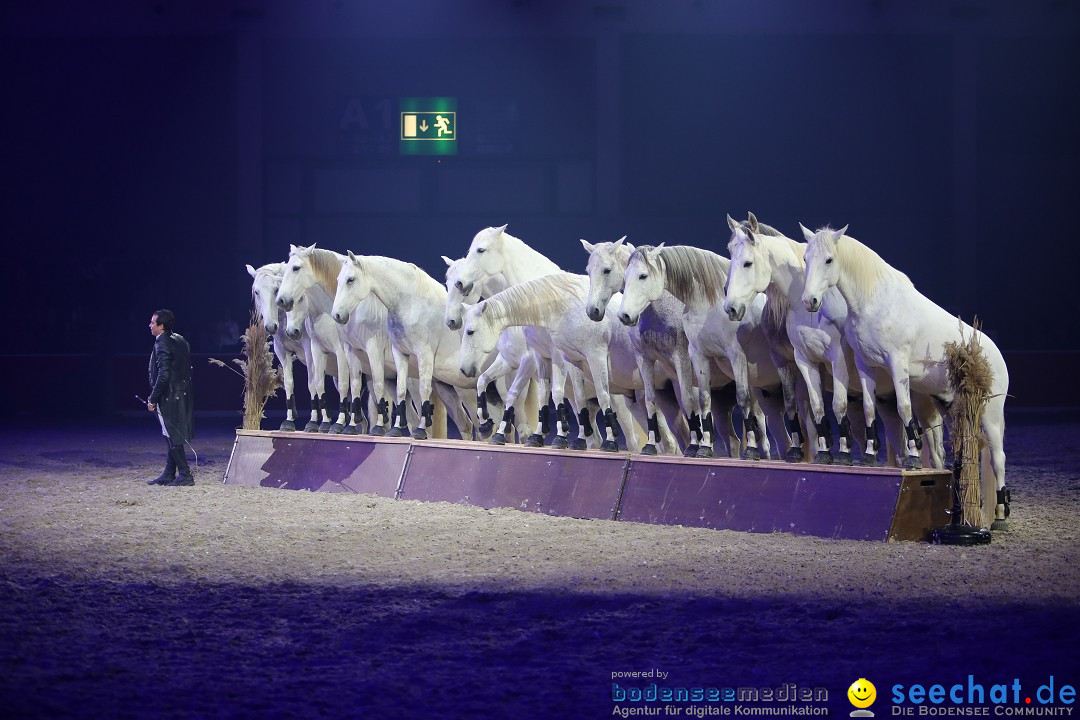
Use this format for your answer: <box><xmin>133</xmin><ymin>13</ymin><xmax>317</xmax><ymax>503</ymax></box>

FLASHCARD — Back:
<box><xmin>401</xmin><ymin>441</ymin><xmax>629</xmax><ymax>519</ymax></box>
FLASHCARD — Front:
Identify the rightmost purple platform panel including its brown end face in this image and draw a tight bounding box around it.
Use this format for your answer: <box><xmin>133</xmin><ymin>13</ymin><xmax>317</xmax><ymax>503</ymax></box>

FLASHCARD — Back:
<box><xmin>618</xmin><ymin>456</ymin><xmax>951</xmax><ymax>541</ymax></box>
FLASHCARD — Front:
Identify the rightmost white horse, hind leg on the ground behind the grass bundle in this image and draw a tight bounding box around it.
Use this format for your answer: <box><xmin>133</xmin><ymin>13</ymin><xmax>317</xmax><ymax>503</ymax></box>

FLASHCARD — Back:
<box><xmin>800</xmin><ymin>225</ymin><xmax>1009</xmax><ymax>529</ymax></box>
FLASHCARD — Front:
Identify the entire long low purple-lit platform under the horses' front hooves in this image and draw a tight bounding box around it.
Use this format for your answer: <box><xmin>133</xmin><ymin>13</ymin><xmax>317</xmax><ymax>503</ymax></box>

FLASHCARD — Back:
<box><xmin>225</xmin><ymin>430</ymin><xmax>953</xmax><ymax>541</ymax></box>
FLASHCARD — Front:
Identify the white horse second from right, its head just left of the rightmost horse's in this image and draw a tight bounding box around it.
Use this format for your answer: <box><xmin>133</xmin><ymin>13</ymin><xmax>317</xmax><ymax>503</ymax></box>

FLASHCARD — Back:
<box><xmin>724</xmin><ymin>213</ymin><xmax>944</xmax><ymax>467</ymax></box>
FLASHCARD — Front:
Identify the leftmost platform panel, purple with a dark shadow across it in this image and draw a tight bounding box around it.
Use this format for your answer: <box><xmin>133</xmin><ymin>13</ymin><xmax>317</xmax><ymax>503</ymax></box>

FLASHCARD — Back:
<box><xmin>225</xmin><ymin>430</ymin><xmax>410</xmax><ymax>498</ymax></box>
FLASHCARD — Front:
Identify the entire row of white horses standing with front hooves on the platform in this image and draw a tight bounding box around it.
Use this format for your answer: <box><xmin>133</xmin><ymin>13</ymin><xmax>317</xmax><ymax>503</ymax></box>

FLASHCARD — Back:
<box><xmin>247</xmin><ymin>214</ymin><xmax>1009</xmax><ymax>527</ymax></box>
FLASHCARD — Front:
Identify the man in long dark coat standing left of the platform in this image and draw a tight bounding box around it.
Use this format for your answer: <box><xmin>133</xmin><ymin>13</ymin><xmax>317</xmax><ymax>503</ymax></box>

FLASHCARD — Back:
<box><xmin>146</xmin><ymin>310</ymin><xmax>195</xmax><ymax>487</ymax></box>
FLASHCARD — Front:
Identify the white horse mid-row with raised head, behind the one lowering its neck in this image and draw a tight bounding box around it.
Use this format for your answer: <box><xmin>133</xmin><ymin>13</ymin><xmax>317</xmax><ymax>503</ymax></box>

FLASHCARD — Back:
<box><xmin>446</xmin><ymin>226</ymin><xmax>592</xmax><ymax>448</ymax></box>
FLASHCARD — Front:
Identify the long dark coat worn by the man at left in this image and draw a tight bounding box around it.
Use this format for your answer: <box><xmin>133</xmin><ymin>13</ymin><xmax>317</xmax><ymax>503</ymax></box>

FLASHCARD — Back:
<box><xmin>147</xmin><ymin>332</ymin><xmax>195</xmax><ymax>445</ymax></box>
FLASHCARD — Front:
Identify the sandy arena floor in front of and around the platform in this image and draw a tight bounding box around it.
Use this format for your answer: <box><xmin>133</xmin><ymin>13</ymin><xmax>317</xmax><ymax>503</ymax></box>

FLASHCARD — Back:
<box><xmin>0</xmin><ymin>416</ymin><xmax>1080</xmax><ymax>718</ymax></box>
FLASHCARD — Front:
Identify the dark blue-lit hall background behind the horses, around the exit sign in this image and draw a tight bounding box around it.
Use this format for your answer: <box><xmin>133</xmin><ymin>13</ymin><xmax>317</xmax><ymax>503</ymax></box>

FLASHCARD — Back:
<box><xmin>0</xmin><ymin>0</ymin><xmax>1080</xmax><ymax>412</ymax></box>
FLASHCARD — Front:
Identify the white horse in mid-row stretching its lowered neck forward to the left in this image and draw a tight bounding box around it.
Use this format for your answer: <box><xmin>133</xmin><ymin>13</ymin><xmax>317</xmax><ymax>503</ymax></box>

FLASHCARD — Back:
<box><xmin>461</xmin><ymin>272</ymin><xmax>648</xmax><ymax>451</ymax></box>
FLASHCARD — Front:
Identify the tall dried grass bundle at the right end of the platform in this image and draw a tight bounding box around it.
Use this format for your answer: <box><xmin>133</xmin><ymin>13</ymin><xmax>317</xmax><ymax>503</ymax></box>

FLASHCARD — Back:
<box><xmin>945</xmin><ymin>317</ymin><xmax>994</xmax><ymax>527</ymax></box>
